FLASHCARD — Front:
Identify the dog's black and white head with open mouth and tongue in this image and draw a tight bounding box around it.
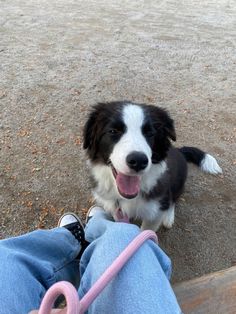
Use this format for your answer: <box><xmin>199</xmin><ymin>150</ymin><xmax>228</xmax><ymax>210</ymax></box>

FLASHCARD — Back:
<box><xmin>83</xmin><ymin>101</ymin><xmax>176</xmax><ymax>198</ymax></box>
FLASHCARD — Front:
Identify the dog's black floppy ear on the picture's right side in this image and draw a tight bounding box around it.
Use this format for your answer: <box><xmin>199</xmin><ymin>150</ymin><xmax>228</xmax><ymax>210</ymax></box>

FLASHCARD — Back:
<box><xmin>148</xmin><ymin>106</ymin><xmax>176</xmax><ymax>141</ymax></box>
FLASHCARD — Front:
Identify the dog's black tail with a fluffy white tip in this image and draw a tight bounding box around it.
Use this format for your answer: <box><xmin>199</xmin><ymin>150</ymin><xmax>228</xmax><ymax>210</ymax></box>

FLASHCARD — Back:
<box><xmin>179</xmin><ymin>146</ymin><xmax>222</xmax><ymax>174</ymax></box>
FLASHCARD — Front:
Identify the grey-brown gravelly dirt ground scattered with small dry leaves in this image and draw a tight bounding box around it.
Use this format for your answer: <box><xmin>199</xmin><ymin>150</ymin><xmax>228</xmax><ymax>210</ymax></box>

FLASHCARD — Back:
<box><xmin>0</xmin><ymin>0</ymin><xmax>236</xmax><ymax>282</ymax></box>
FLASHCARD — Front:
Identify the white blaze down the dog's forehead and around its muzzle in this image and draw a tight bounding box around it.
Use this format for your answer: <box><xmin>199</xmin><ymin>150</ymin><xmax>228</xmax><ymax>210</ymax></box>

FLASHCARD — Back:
<box><xmin>110</xmin><ymin>104</ymin><xmax>152</xmax><ymax>174</ymax></box>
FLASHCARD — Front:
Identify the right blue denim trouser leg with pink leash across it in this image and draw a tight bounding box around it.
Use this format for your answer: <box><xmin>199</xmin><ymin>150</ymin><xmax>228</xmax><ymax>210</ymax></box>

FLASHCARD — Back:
<box><xmin>79</xmin><ymin>211</ymin><xmax>181</xmax><ymax>314</ymax></box>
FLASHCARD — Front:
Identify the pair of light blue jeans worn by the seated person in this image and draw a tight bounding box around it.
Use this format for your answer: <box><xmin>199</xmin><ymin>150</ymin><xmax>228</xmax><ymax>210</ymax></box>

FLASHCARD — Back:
<box><xmin>0</xmin><ymin>212</ymin><xmax>181</xmax><ymax>314</ymax></box>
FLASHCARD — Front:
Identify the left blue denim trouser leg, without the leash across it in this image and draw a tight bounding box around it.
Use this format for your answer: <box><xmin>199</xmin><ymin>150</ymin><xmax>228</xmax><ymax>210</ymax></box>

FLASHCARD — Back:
<box><xmin>0</xmin><ymin>228</ymin><xmax>80</xmax><ymax>314</ymax></box>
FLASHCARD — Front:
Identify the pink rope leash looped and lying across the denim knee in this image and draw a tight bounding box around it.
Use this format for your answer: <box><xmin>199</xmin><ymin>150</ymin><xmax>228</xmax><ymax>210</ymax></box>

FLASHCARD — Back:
<box><xmin>39</xmin><ymin>230</ymin><xmax>157</xmax><ymax>314</ymax></box>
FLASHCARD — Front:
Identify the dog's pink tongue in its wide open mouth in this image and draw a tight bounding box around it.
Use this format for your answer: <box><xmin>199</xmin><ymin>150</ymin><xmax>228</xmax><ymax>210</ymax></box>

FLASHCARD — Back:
<box><xmin>116</xmin><ymin>173</ymin><xmax>140</xmax><ymax>198</ymax></box>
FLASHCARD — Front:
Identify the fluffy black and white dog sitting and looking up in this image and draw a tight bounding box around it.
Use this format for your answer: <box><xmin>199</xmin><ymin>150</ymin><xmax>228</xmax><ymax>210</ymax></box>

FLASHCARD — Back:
<box><xmin>83</xmin><ymin>101</ymin><xmax>222</xmax><ymax>231</ymax></box>
